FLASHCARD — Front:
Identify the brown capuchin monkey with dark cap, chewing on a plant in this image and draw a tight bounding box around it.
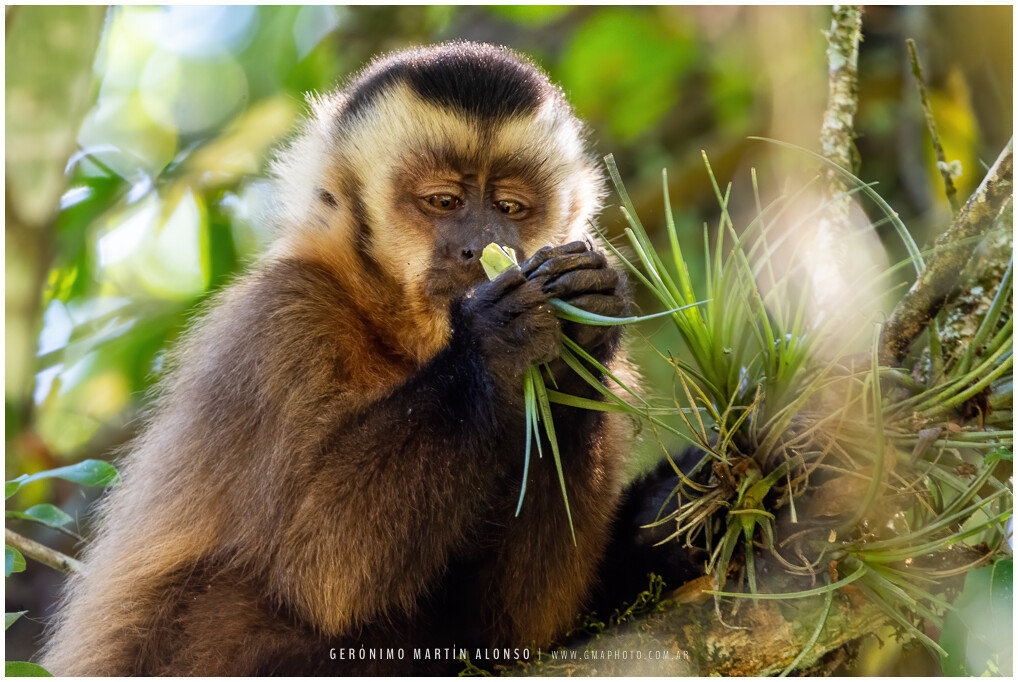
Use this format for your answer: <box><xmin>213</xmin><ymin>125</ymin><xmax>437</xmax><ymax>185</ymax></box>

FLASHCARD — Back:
<box><xmin>42</xmin><ymin>43</ymin><xmax>692</xmax><ymax>675</ymax></box>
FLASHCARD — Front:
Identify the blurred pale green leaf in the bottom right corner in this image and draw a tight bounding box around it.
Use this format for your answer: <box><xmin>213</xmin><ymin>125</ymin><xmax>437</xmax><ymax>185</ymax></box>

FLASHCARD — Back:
<box><xmin>939</xmin><ymin>557</ymin><xmax>1014</xmax><ymax>677</ymax></box>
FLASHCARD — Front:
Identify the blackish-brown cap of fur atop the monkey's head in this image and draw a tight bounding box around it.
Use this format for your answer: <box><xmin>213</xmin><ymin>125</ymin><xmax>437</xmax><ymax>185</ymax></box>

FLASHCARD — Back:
<box><xmin>343</xmin><ymin>42</ymin><xmax>564</xmax><ymax>120</ymax></box>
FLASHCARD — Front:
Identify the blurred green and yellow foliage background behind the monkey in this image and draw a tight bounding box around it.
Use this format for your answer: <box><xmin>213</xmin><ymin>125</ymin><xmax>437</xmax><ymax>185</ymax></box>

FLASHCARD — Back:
<box><xmin>5</xmin><ymin>6</ymin><xmax>1013</xmax><ymax>674</ymax></box>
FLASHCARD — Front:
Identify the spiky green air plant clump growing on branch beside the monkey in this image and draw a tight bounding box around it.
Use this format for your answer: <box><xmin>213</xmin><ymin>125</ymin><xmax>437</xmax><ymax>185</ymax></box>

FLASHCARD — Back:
<box><xmin>594</xmin><ymin>149</ymin><xmax>1013</xmax><ymax>673</ymax></box>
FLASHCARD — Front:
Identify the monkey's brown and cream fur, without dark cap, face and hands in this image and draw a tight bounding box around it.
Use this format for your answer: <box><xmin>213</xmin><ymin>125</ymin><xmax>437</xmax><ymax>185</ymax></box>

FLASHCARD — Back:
<box><xmin>43</xmin><ymin>44</ymin><xmax>630</xmax><ymax>675</ymax></box>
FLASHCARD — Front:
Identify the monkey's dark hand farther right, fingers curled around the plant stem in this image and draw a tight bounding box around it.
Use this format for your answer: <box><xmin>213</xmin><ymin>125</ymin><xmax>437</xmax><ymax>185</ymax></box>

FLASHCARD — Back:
<box><xmin>521</xmin><ymin>241</ymin><xmax>630</xmax><ymax>362</ymax></box>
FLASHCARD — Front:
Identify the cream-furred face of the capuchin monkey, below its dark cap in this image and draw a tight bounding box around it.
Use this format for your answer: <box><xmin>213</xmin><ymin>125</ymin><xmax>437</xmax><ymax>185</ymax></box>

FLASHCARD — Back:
<box><xmin>333</xmin><ymin>86</ymin><xmax>601</xmax><ymax>305</ymax></box>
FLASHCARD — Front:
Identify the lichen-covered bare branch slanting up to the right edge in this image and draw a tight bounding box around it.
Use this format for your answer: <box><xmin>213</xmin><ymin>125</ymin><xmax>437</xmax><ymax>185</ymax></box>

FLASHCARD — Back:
<box><xmin>881</xmin><ymin>135</ymin><xmax>1014</xmax><ymax>364</ymax></box>
